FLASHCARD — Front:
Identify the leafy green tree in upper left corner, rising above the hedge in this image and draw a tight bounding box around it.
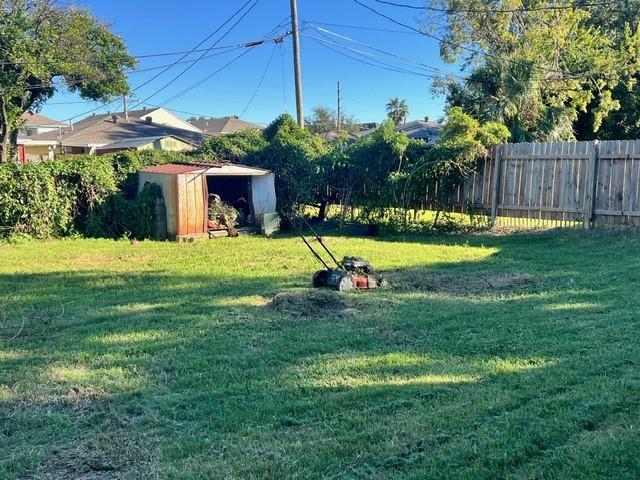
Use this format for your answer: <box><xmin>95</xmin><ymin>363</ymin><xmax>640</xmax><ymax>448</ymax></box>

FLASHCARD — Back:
<box><xmin>0</xmin><ymin>0</ymin><xmax>136</xmax><ymax>162</ymax></box>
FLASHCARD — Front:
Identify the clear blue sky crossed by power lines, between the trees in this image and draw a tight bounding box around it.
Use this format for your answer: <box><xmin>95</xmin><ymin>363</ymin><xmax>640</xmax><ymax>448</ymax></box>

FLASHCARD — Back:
<box><xmin>43</xmin><ymin>0</ymin><xmax>455</xmax><ymax>124</ymax></box>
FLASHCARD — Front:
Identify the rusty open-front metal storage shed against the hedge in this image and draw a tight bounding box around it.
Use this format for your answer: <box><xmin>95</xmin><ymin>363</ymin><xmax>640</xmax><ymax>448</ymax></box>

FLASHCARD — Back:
<box><xmin>139</xmin><ymin>163</ymin><xmax>279</xmax><ymax>239</ymax></box>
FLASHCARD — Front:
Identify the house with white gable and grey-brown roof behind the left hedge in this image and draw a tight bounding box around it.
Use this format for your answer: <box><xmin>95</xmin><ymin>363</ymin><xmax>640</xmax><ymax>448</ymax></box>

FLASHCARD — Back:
<box><xmin>24</xmin><ymin>108</ymin><xmax>204</xmax><ymax>155</ymax></box>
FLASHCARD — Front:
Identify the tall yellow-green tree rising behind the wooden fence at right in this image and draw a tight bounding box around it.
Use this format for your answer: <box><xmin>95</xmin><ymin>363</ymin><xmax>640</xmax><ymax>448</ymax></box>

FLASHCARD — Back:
<box><xmin>428</xmin><ymin>0</ymin><xmax>640</xmax><ymax>141</ymax></box>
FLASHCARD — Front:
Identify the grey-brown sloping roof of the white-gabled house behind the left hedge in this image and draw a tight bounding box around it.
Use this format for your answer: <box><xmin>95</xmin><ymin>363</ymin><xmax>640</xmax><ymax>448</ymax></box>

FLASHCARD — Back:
<box><xmin>30</xmin><ymin>114</ymin><xmax>203</xmax><ymax>148</ymax></box>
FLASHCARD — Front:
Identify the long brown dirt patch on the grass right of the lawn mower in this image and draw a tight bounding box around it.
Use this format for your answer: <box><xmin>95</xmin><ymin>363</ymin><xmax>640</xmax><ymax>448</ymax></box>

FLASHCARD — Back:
<box><xmin>385</xmin><ymin>271</ymin><xmax>536</xmax><ymax>296</ymax></box>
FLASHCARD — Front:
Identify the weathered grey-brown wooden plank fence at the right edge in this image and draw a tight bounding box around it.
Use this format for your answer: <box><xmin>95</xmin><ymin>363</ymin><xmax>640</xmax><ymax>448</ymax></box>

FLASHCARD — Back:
<box><xmin>451</xmin><ymin>140</ymin><xmax>640</xmax><ymax>228</ymax></box>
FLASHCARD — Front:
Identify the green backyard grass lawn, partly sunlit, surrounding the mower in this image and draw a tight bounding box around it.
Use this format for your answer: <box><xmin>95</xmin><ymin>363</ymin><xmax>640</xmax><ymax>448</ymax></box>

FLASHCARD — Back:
<box><xmin>0</xmin><ymin>231</ymin><xmax>640</xmax><ymax>480</ymax></box>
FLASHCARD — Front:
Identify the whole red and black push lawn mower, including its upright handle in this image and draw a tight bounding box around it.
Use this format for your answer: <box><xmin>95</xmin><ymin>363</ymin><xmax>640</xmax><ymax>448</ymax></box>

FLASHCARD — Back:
<box><xmin>289</xmin><ymin>215</ymin><xmax>388</xmax><ymax>292</ymax></box>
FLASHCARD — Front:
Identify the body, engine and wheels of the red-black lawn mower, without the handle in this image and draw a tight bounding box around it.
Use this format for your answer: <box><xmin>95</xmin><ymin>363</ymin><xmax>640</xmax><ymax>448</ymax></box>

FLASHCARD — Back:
<box><xmin>313</xmin><ymin>257</ymin><xmax>387</xmax><ymax>292</ymax></box>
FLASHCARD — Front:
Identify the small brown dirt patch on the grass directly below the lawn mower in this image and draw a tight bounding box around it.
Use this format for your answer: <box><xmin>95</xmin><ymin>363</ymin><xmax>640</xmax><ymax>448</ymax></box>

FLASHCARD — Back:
<box><xmin>264</xmin><ymin>289</ymin><xmax>359</xmax><ymax>316</ymax></box>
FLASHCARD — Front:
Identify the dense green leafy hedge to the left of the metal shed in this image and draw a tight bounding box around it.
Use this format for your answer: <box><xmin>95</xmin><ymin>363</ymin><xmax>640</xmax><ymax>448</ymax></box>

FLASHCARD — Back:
<box><xmin>0</xmin><ymin>150</ymin><xmax>190</xmax><ymax>238</ymax></box>
